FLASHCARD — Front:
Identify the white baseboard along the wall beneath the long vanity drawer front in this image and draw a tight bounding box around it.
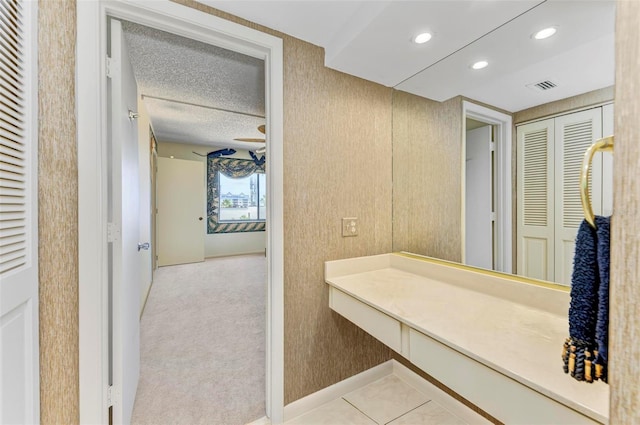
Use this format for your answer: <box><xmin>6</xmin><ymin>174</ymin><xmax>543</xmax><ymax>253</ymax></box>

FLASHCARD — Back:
<box><xmin>391</xmin><ymin>360</ymin><xmax>491</xmax><ymax>425</ymax></box>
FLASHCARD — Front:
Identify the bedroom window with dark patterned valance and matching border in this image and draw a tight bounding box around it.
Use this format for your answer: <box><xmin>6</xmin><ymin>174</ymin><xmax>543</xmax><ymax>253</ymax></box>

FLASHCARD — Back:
<box><xmin>207</xmin><ymin>157</ymin><xmax>267</xmax><ymax>233</ymax></box>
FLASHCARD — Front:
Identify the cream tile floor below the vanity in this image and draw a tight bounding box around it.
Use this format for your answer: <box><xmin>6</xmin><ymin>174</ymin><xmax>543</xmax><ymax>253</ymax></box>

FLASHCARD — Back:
<box><xmin>285</xmin><ymin>374</ymin><xmax>467</xmax><ymax>425</ymax></box>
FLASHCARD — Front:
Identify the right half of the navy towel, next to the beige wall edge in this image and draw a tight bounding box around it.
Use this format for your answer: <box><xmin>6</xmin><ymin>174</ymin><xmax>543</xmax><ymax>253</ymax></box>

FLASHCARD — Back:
<box><xmin>596</xmin><ymin>216</ymin><xmax>611</xmax><ymax>382</ymax></box>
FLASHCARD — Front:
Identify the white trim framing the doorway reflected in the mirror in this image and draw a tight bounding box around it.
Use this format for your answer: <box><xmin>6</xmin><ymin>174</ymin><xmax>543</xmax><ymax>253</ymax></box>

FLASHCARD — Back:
<box><xmin>462</xmin><ymin>101</ymin><xmax>513</xmax><ymax>273</ymax></box>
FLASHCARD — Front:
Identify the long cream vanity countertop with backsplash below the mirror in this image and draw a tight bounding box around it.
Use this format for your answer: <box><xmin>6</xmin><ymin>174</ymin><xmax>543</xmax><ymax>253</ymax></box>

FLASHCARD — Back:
<box><xmin>326</xmin><ymin>254</ymin><xmax>609</xmax><ymax>423</ymax></box>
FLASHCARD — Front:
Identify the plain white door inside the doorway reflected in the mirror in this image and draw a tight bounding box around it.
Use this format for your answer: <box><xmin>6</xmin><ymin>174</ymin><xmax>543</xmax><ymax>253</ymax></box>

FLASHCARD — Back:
<box><xmin>464</xmin><ymin>125</ymin><xmax>493</xmax><ymax>269</ymax></box>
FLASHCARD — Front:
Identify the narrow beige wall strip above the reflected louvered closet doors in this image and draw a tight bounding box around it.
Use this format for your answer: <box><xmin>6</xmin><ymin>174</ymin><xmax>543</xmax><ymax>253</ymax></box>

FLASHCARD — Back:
<box><xmin>513</xmin><ymin>86</ymin><xmax>614</xmax><ymax>123</ymax></box>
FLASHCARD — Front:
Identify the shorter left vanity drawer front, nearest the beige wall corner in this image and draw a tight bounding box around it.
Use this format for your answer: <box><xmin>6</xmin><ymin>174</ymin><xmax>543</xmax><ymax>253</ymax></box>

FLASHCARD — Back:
<box><xmin>329</xmin><ymin>287</ymin><xmax>402</xmax><ymax>353</ymax></box>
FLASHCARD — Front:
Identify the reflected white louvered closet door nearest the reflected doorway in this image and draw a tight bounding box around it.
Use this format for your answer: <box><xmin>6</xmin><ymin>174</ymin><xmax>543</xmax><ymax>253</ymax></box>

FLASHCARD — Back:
<box><xmin>517</xmin><ymin>119</ymin><xmax>554</xmax><ymax>280</ymax></box>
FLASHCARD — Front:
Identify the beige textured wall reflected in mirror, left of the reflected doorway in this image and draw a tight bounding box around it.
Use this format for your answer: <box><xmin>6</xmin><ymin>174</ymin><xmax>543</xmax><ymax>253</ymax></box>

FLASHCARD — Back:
<box><xmin>393</xmin><ymin>91</ymin><xmax>463</xmax><ymax>261</ymax></box>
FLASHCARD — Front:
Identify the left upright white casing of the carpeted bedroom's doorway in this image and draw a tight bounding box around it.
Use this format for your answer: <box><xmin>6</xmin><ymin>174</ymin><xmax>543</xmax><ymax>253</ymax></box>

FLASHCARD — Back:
<box><xmin>76</xmin><ymin>1</ymin><xmax>108</xmax><ymax>424</ymax></box>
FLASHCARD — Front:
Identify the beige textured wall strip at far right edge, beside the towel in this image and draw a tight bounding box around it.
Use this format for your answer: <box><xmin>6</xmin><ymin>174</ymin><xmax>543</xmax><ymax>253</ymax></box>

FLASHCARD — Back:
<box><xmin>609</xmin><ymin>1</ymin><xmax>640</xmax><ymax>425</ymax></box>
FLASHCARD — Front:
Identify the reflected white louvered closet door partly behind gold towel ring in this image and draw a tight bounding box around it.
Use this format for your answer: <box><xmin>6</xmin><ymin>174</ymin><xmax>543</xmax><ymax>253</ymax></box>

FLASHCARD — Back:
<box><xmin>554</xmin><ymin>108</ymin><xmax>602</xmax><ymax>285</ymax></box>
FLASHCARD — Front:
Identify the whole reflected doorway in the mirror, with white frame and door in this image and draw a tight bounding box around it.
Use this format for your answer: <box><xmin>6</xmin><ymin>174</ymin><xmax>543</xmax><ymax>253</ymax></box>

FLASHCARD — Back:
<box><xmin>462</xmin><ymin>101</ymin><xmax>513</xmax><ymax>273</ymax></box>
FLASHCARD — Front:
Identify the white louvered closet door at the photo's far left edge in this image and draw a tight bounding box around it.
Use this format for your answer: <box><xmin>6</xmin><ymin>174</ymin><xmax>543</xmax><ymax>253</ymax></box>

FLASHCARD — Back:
<box><xmin>0</xmin><ymin>0</ymin><xmax>40</xmax><ymax>424</ymax></box>
